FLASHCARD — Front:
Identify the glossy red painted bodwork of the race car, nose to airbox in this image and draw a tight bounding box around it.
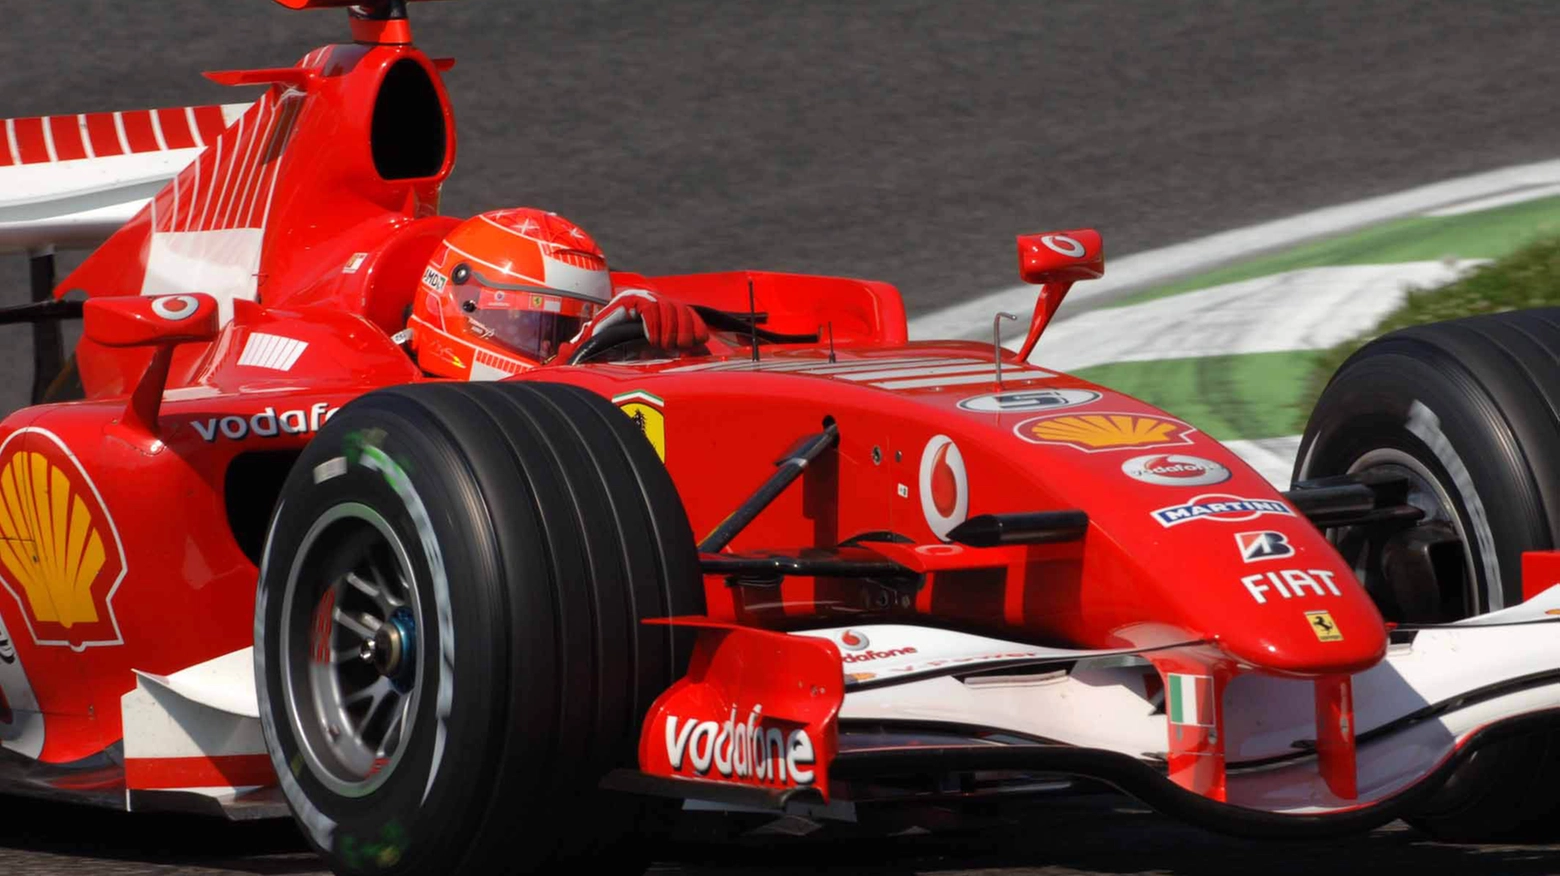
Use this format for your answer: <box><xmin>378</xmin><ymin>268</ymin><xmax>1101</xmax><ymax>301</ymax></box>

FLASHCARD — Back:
<box><xmin>0</xmin><ymin>2</ymin><xmax>1387</xmax><ymax>798</ymax></box>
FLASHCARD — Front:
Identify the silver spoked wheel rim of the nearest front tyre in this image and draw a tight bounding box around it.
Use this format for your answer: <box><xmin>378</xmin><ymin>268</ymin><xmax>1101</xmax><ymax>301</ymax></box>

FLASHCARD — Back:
<box><xmin>279</xmin><ymin>502</ymin><xmax>426</xmax><ymax>797</ymax></box>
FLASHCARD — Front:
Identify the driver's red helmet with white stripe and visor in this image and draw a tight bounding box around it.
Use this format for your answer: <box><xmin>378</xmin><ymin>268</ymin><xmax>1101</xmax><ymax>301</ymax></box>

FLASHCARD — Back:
<box><xmin>409</xmin><ymin>207</ymin><xmax>612</xmax><ymax>380</ymax></box>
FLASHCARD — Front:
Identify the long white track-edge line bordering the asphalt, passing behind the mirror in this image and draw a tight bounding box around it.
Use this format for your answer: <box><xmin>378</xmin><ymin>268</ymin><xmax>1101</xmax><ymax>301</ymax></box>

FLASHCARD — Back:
<box><xmin>909</xmin><ymin>159</ymin><xmax>1560</xmax><ymax>341</ymax></box>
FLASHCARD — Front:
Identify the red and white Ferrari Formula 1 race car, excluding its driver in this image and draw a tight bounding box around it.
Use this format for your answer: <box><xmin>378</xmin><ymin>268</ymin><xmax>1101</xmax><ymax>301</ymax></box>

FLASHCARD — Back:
<box><xmin>0</xmin><ymin>0</ymin><xmax>1560</xmax><ymax>873</ymax></box>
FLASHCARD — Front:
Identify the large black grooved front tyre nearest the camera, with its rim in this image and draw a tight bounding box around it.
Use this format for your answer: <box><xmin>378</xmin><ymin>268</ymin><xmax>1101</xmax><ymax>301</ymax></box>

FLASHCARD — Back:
<box><xmin>254</xmin><ymin>382</ymin><xmax>704</xmax><ymax>874</ymax></box>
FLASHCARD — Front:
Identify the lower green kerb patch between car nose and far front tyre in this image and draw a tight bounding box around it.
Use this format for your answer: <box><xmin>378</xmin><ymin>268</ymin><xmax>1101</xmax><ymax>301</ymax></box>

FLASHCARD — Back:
<box><xmin>1076</xmin><ymin>351</ymin><xmax>1317</xmax><ymax>441</ymax></box>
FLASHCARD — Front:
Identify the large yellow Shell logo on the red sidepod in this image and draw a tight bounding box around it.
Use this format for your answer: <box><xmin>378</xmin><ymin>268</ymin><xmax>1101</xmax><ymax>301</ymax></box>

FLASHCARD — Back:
<box><xmin>0</xmin><ymin>429</ymin><xmax>125</xmax><ymax>650</ymax></box>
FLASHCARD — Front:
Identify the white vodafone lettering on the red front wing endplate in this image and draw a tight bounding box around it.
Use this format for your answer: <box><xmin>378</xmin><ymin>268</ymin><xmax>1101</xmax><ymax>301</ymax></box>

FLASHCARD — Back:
<box><xmin>666</xmin><ymin>706</ymin><xmax>817</xmax><ymax>787</ymax></box>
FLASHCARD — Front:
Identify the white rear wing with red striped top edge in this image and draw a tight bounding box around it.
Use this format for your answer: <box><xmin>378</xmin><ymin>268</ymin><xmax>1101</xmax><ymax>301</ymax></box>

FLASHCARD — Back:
<box><xmin>0</xmin><ymin>103</ymin><xmax>250</xmax><ymax>253</ymax></box>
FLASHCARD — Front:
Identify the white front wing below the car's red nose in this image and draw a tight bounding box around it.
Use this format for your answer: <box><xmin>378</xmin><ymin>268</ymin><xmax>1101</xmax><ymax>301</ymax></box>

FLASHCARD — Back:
<box><xmin>805</xmin><ymin>588</ymin><xmax>1560</xmax><ymax>814</ymax></box>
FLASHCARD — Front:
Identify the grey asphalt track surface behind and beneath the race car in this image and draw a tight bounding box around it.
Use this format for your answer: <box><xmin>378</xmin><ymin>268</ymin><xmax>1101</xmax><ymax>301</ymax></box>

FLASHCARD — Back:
<box><xmin>0</xmin><ymin>0</ymin><xmax>1560</xmax><ymax>876</ymax></box>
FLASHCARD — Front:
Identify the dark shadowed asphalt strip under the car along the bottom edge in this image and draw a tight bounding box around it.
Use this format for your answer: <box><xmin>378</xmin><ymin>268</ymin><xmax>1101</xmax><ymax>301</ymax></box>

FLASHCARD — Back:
<box><xmin>9</xmin><ymin>795</ymin><xmax>1560</xmax><ymax>876</ymax></box>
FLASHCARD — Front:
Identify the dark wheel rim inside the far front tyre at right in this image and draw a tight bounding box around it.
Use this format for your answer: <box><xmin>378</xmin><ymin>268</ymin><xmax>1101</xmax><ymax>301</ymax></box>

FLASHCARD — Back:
<box><xmin>1329</xmin><ymin>447</ymin><xmax>1482</xmax><ymax>623</ymax></box>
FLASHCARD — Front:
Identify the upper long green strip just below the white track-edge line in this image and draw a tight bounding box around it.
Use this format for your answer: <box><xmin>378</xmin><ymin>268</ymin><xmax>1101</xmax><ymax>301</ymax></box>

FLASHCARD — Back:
<box><xmin>1111</xmin><ymin>196</ymin><xmax>1560</xmax><ymax>307</ymax></box>
